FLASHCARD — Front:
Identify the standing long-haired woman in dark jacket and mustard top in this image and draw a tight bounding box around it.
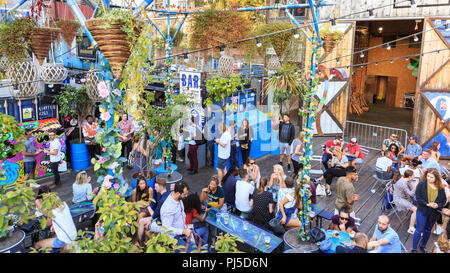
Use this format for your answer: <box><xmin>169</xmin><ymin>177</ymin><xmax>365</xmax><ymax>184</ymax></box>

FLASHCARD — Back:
<box><xmin>411</xmin><ymin>168</ymin><xmax>447</xmax><ymax>253</ymax></box>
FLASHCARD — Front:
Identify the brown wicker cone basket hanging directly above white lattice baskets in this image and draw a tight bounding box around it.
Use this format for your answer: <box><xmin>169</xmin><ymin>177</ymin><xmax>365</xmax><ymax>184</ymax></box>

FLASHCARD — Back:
<box><xmin>31</xmin><ymin>27</ymin><xmax>60</xmax><ymax>64</ymax></box>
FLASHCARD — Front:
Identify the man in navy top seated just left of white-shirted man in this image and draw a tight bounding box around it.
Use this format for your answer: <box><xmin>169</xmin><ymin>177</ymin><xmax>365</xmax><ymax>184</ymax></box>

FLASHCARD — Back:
<box><xmin>138</xmin><ymin>178</ymin><xmax>170</xmax><ymax>245</ymax></box>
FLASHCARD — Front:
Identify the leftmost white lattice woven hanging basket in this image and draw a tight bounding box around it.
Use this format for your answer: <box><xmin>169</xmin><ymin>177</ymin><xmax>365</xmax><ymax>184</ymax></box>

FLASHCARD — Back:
<box><xmin>6</xmin><ymin>59</ymin><xmax>39</xmax><ymax>99</ymax></box>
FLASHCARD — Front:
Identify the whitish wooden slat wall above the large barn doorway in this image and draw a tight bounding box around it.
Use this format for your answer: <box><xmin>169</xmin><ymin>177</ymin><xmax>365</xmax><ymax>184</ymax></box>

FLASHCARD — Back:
<box><xmin>320</xmin><ymin>0</ymin><xmax>450</xmax><ymax>20</ymax></box>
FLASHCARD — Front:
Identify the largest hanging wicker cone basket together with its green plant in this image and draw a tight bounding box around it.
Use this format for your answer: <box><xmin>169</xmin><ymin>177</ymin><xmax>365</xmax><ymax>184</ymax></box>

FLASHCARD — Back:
<box><xmin>86</xmin><ymin>6</ymin><xmax>143</xmax><ymax>78</ymax></box>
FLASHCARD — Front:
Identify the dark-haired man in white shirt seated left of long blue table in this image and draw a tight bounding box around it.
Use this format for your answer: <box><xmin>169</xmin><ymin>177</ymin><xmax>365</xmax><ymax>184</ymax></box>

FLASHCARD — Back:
<box><xmin>160</xmin><ymin>181</ymin><xmax>192</xmax><ymax>238</ymax></box>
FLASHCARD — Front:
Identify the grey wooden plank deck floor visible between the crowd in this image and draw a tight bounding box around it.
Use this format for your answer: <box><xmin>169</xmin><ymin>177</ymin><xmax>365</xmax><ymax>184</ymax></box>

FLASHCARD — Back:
<box><xmin>29</xmin><ymin>137</ymin><xmax>446</xmax><ymax>251</ymax></box>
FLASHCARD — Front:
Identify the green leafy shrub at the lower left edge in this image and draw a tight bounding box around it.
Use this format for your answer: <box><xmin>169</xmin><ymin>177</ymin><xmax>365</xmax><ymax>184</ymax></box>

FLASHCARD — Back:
<box><xmin>0</xmin><ymin>184</ymin><xmax>34</xmax><ymax>237</ymax></box>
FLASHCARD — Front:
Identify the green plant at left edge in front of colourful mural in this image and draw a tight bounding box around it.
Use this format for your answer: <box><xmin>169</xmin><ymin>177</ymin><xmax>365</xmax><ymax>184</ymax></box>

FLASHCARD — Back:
<box><xmin>0</xmin><ymin>113</ymin><xmax>25</xmax><ymax>162</ymax></box>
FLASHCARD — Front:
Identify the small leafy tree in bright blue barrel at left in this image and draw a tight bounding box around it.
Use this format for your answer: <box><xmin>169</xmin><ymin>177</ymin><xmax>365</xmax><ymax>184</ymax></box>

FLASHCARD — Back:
<box><xmin>53</xmin><ymin>85</ymin><xmax>94</xmax><ymax>168</ymax></box>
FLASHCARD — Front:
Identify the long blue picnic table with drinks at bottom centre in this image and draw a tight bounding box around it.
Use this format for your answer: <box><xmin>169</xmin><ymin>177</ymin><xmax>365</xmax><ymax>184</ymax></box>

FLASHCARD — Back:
<box><xmin>205</xmin><ymin>207</ymin><xmax>282</xmax><ymax>253</ymax></box>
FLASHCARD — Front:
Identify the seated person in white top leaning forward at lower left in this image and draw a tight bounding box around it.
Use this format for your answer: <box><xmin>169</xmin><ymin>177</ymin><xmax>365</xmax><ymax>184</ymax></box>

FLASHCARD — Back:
<box><xmin>34</xmin><ymin>202</ymin><xmax>77</xmax><ymax>249</ymax></box>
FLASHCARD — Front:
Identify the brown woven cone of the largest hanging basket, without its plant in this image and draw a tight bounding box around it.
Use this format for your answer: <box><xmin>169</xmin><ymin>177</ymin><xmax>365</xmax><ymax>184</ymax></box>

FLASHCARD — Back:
<box><xmin>86</xmin><ymin>18</ymin><xmax>142</xmax><ymax>78</ymax></box>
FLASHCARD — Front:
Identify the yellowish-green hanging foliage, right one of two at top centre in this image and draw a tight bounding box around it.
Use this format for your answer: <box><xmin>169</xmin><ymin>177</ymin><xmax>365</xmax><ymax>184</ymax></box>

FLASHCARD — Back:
<box><xmin>245</xmin><ymin>23</ymin><xmax>304</xmax><ymax>59</ymax></box>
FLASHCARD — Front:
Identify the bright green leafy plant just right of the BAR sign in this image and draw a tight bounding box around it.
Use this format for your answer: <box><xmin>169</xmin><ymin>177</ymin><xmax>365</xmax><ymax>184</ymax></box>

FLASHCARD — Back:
<box><xmin>205</xmin><ymin>73</ymin><xmax>244</xmax><ymax>111</ymax></box>
